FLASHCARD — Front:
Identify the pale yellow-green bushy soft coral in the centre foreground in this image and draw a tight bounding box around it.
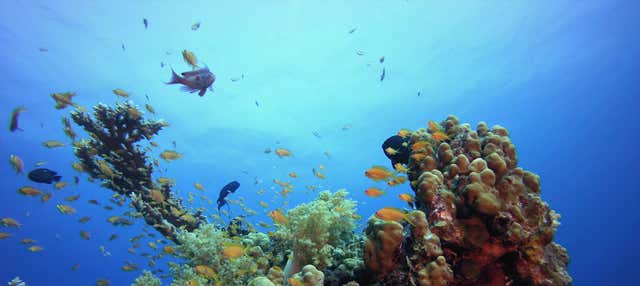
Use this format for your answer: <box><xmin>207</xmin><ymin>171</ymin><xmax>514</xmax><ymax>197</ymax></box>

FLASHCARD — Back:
<box><xmin>273</xmin><ymin>190</ymin><xmax>362</xmax><ymax>283</ymax></box>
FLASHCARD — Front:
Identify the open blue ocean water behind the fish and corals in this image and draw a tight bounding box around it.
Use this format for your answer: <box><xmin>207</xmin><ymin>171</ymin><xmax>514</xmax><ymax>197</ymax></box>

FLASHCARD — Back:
<box><xmin>0</xmin><ymin>0</ymin><xmax>640</xmax><ymax>285</ymax></box>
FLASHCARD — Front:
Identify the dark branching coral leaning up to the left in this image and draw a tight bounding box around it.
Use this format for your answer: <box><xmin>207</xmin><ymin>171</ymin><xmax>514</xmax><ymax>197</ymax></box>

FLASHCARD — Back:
<box><xmin>71</xmin><ymin>102</ymin><xmax>203</xmax><ymax>242</ymax></box>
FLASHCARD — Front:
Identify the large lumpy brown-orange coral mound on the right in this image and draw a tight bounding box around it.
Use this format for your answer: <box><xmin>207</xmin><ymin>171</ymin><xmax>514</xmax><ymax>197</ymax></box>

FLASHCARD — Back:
<box><xmin>364</xmin><ymin>116</ymin><xmax>571</xmax><ymax>285</ymax></box>
